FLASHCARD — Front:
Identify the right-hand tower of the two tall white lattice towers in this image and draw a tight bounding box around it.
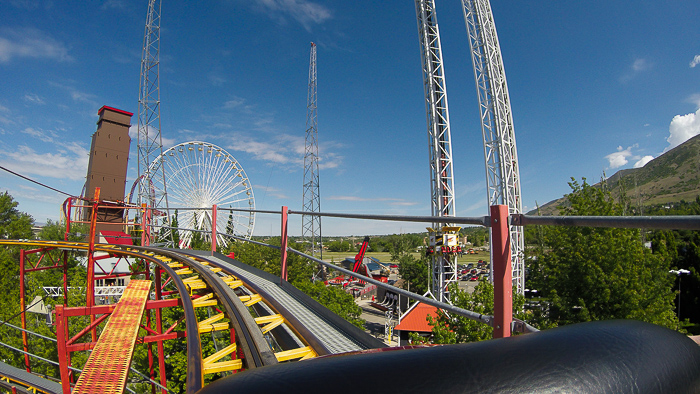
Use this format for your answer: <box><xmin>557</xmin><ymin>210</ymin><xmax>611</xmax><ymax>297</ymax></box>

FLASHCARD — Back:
<box><xmin>462</xmin><ymin>0</ymin><xmax>525</xmax><ymax>294</ymax></box>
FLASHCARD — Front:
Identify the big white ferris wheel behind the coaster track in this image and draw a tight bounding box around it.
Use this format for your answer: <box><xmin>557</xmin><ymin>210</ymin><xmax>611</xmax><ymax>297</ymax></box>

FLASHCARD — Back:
<box><xmin>151</xmin><ymin>141</ymin><xmax>255</xmax><ymax>248</ymax></box>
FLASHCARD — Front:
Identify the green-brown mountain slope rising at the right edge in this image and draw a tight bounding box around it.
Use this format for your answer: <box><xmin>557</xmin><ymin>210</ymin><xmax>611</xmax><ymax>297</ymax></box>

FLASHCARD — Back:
<box><xmin>527</xmin><ymin>135</ymin><xmax>700</xmax><ymax>216</ymax></box>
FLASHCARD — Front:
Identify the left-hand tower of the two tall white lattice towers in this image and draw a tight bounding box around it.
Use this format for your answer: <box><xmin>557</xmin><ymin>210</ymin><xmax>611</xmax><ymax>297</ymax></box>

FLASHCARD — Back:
<box><xmin>416</xmin><ymin>0</ymin><xmax>457</xmax><ymax>301</ymax></box>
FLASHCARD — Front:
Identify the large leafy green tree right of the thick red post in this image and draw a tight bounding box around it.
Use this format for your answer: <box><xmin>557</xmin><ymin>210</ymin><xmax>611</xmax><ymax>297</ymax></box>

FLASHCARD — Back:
<box><xmin>529</xmin><ymin>178</ymin><xmax>677</xmax><ymax>328</ymax></box>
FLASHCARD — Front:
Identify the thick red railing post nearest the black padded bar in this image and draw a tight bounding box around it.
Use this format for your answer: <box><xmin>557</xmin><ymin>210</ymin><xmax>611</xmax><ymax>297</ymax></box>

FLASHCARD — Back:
<box><xmin>491</xmin><ymin>205</ymin><xmax>513</xmax><ymax>338</ymax></box>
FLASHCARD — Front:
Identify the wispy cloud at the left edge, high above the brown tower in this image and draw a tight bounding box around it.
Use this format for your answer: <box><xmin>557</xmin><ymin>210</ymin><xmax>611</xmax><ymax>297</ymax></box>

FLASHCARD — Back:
<box><xmin>0</xmin><ymin>28</ymin><xmax>73</xmax><ymax>63</ymax></box>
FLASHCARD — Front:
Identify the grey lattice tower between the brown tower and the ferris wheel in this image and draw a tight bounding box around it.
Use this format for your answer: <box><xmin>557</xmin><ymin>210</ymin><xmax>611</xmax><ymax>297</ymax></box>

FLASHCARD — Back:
<box><xmin>138</xmin><ymin>0</ymin><xmax>169</xmax><ymax>240</ymax></box>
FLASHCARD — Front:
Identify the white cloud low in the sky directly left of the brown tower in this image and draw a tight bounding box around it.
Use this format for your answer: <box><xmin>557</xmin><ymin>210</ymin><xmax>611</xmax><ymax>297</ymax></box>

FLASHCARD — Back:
<box><xmin>0</xmin><ymin>143</ymin><xmax>89</xmax><ymax>181</ymax></box>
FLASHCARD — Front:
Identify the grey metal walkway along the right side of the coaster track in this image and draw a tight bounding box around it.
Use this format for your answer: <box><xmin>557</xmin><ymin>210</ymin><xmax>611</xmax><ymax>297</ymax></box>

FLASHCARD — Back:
<box><xmin>185</xmin><ymin>251</ymin><xmax>386</xmax><ymax>354</ymax></box>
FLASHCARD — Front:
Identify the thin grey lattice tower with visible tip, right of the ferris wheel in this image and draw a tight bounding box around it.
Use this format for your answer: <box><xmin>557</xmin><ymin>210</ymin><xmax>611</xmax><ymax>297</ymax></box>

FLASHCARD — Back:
<box><xmin>301</xmin><ymin>42</ymin><xmax>323</xmax><ymax>257</ymax></box>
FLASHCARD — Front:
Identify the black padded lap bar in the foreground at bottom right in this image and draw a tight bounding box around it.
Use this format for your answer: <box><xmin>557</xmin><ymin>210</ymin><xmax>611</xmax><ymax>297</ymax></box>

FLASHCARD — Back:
<box><xmin>199</xmin><ymin>320</ymin><xmax>700</xmax><ymax>394</ymax></box>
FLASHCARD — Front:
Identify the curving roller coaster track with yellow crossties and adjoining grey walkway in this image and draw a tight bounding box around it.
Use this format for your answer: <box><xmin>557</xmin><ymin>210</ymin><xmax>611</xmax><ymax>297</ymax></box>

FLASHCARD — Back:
<box><xmin>0</xmin><ymin>240</ymin><xmax>383</xmax><ymax>393</ymax></box>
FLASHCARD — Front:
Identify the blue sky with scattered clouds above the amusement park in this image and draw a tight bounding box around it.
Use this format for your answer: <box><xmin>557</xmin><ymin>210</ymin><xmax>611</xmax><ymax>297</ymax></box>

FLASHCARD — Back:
<box><xmin>0</xmin><ymin>0</ymin><xmax>700</xmax><ymax>235</ymax></box>
